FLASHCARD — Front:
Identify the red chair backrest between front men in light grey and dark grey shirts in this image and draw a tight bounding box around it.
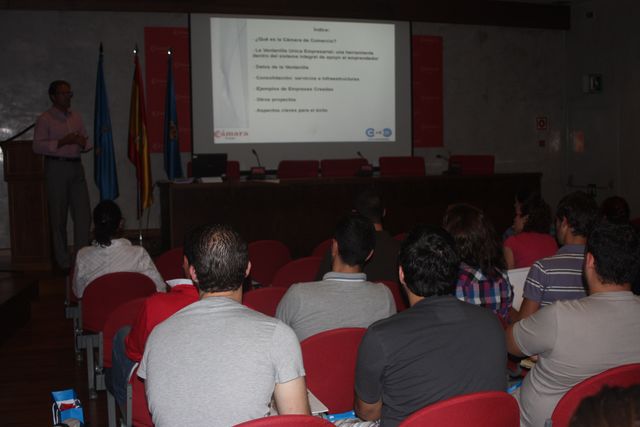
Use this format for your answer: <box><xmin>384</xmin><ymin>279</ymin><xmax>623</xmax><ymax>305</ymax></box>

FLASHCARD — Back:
<box><xmin>300</xmin><ymin>328</ymin><xmax>367</xmax><ymax>414</ymax></box>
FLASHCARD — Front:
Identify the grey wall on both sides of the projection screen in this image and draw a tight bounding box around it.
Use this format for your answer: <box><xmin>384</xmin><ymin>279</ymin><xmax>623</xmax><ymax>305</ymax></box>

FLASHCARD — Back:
<box><xmin>0</xmin><ymin>6</ymin><xmax>640</xmax><ymax>248</ymax></box>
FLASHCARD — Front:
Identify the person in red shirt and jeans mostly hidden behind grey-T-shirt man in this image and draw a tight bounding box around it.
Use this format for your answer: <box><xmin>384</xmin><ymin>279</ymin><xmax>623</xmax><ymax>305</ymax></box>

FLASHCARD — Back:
<box><xmin>106</xmin><ymin>234</ymin><xmax>199</xmax><ymax>408</ymax></box>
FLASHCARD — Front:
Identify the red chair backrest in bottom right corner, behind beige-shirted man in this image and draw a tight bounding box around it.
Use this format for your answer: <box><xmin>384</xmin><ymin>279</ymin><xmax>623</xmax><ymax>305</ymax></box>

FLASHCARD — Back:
<box><xmin>551</xmin><ymin>363</ymin><xmax>640</xmax><ymax>427</ymax></box>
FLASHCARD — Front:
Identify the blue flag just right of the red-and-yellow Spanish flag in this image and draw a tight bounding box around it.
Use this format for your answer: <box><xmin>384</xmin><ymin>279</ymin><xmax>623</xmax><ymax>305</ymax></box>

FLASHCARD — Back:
<box><xmin>164</xmin><ymin>50</ymin><xmax>182</xmax><ymax>180</ymax></box>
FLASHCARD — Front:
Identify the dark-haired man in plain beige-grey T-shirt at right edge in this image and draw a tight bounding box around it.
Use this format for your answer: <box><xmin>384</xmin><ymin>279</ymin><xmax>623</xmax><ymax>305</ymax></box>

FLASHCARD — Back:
<box><xmin>507</xmin><ymin>222</ymin><xmax>640</xmax><ymax>427</ymax></box>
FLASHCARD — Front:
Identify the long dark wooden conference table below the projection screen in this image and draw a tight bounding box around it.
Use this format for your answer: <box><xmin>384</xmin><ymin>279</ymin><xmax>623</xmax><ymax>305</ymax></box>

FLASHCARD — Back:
<box><xmin>159</xmin><ymin>173</ymin><xmax>541</xmax><ymax>258</ymax></box>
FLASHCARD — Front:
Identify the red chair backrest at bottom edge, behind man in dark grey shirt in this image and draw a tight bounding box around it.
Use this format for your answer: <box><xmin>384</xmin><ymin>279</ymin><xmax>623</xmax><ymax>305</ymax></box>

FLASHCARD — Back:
<box><xmin>400</xmin><ymin>391</ymin><xmax>520</xmax><ymax>427</ymax></box>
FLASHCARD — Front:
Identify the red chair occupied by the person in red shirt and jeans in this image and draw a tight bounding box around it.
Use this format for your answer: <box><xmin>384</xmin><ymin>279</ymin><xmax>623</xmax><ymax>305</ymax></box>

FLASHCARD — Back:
<box><xmin>104</xmin><ymin>298</ymin><xmax>146</xmax><ymax>426</ymax></box>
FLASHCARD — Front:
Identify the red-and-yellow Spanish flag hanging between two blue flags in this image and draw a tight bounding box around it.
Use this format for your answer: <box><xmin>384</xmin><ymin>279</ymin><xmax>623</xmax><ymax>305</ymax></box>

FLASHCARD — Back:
<box><xmin>129</xmin><ymin>49</ymin><xmax>153</xmax><ymax>218</ymax></box>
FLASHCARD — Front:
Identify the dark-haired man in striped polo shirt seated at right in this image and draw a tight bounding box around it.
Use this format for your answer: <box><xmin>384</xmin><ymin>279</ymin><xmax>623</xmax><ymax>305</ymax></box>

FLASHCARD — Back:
<box><xmin>512</xmin><ymin>191</ymin><xmax>598</xmax><ymax>320</ymax></box>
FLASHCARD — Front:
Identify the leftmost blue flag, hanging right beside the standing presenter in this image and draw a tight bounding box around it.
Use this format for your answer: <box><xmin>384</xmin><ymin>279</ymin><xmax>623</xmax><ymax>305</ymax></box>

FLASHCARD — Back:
<box><xmin>93</xmin><ymin>44</ymin><xmax>120</xmax><ymax>201</ymax></box>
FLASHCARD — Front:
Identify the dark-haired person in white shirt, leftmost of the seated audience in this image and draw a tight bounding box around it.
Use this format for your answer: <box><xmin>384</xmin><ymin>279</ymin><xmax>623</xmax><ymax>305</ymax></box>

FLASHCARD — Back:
<box><xmin>73</xmin><ymin>200</ymin><xmax>166</xmax><ymax>298</ymax></box>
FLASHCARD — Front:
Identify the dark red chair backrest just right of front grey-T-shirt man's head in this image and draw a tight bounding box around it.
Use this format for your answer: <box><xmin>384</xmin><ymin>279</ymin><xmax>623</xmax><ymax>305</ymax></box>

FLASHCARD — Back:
<box><xmin>249</xmin><ymin>240</ymin><xmax>291</xmax><ymax>286</ymax></box>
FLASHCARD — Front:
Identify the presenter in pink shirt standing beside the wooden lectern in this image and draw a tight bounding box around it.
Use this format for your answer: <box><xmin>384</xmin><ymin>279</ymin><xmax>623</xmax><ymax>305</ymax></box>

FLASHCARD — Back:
<box><xmin>33</xmin><ymin>80</ymin><xmax>92</xmax><ymax>270</ymax></box>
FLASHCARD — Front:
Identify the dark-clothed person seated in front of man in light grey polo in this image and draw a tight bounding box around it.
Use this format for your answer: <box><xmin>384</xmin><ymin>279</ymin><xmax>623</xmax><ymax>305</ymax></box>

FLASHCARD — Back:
<box><xmin>316</xmin><ymin>190</ymin><xmax>400</xmax><ymax>283</ymax></box>
